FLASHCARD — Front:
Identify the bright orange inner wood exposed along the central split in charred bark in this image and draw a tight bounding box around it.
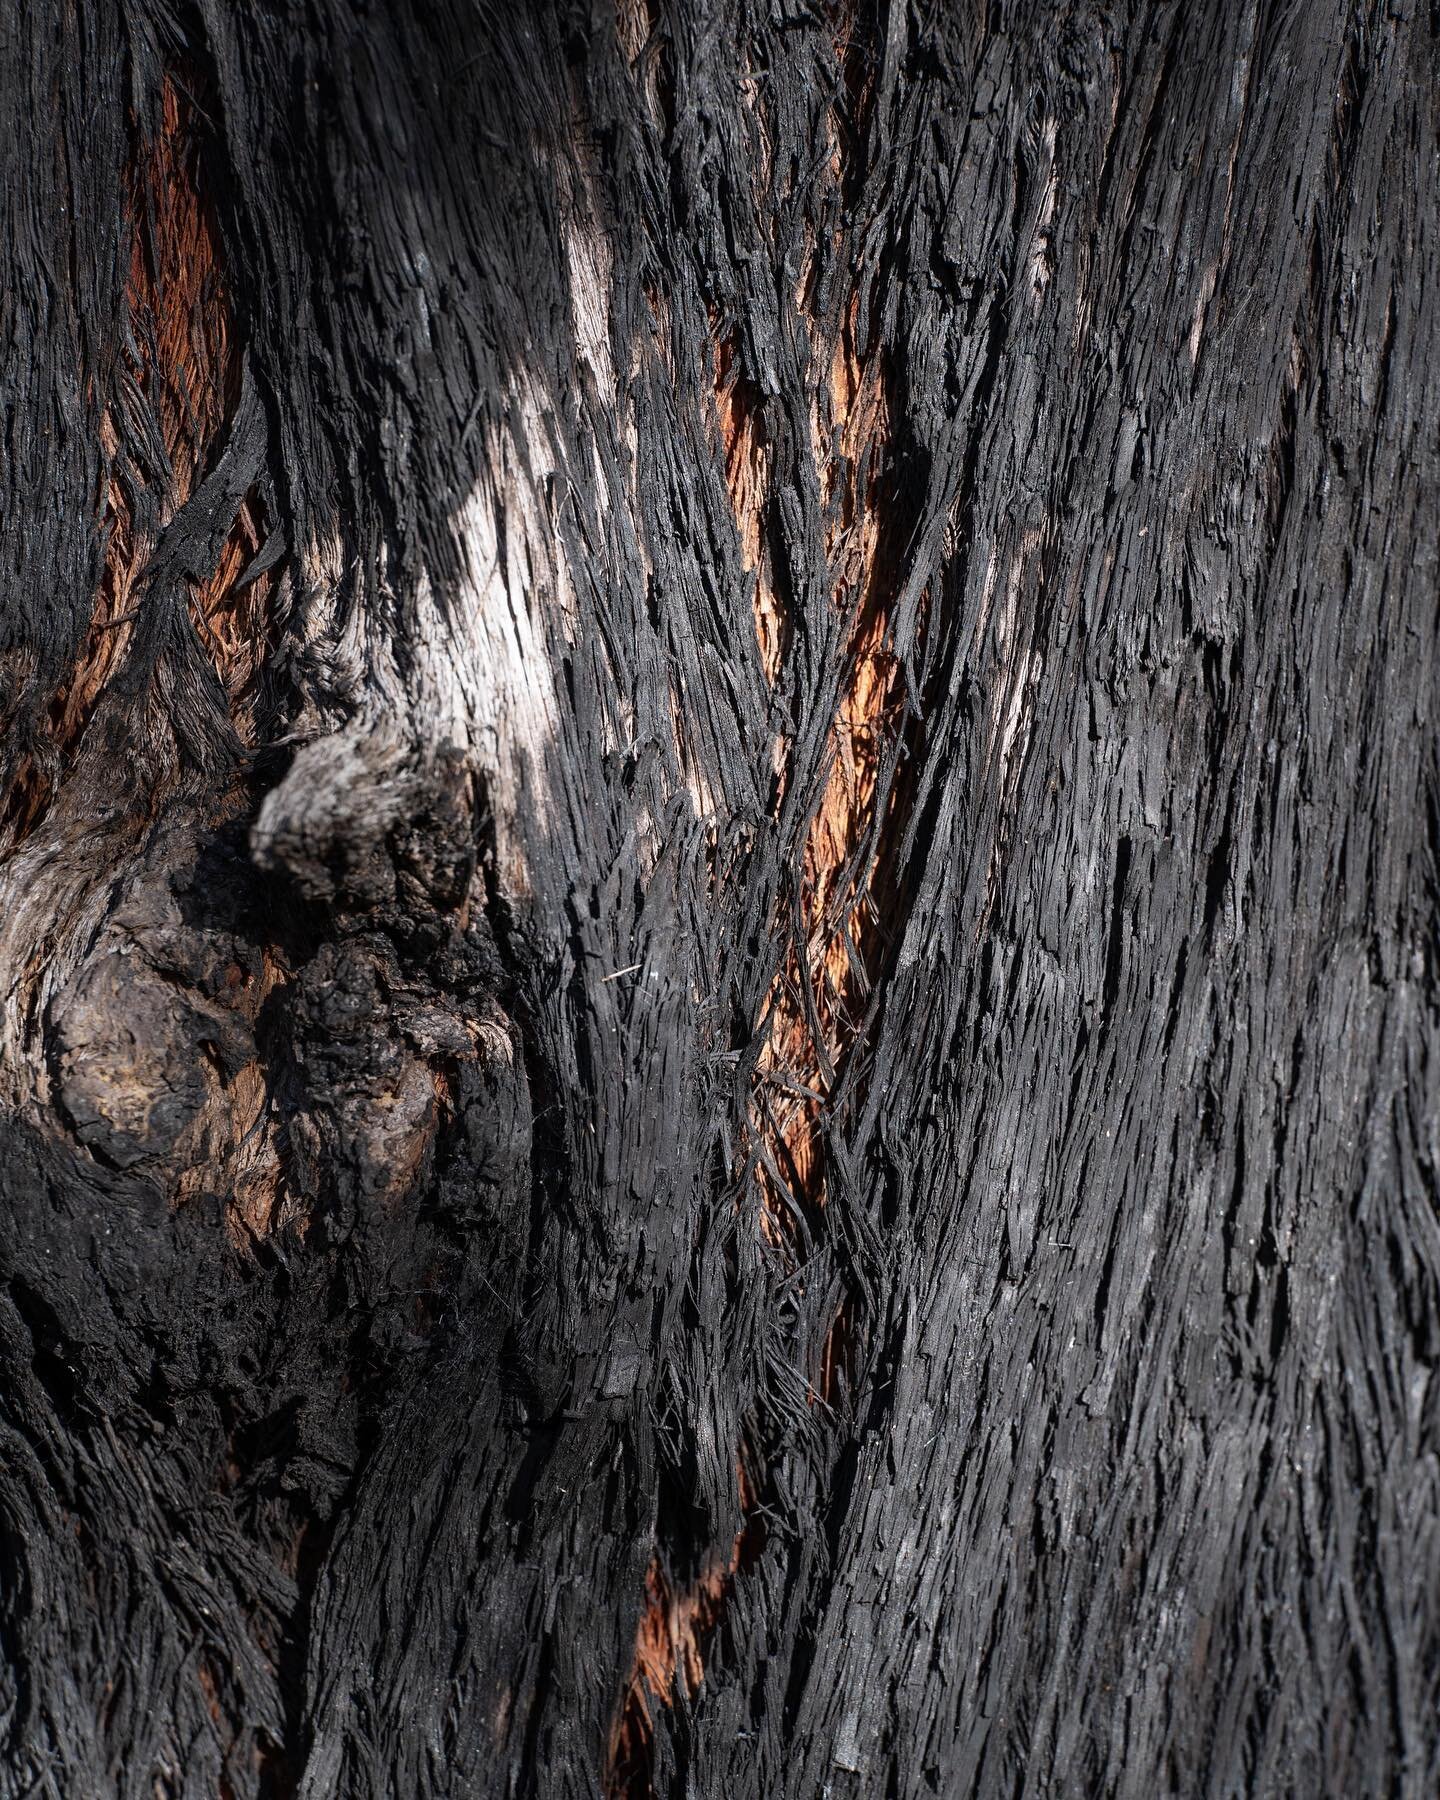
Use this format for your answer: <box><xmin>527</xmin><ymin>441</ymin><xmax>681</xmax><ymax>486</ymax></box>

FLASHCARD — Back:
<box><xmin>608</xmin><ymin>17</ymin><xmax>918</xmax><ymax>1795</ymax></box>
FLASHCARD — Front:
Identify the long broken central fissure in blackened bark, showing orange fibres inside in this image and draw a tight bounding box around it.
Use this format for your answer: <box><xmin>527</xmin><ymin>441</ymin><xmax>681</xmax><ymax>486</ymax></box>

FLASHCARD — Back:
<box><xmin>608</xmin><ymin>16</ymin><xmax>923</xmax><ymax>1795</ymax></box>
